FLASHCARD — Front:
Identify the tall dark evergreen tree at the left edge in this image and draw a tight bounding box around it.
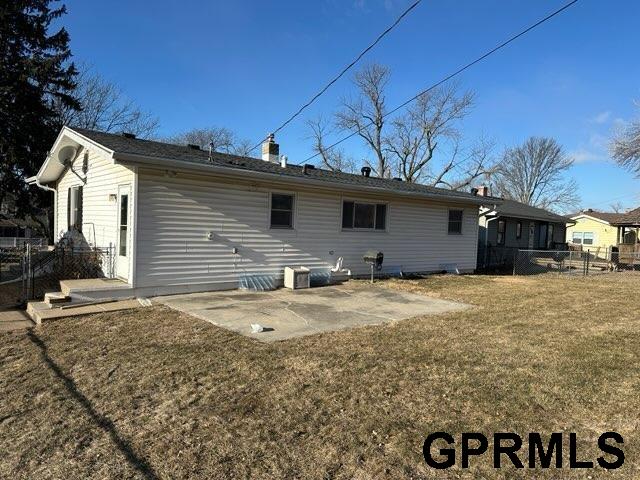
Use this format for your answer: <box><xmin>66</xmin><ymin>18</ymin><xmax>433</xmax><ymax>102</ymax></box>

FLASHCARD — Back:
<box><xmin>0</xmin><ymin>0</ymin><xmax>79</xmax><ymax>233</ymax></box>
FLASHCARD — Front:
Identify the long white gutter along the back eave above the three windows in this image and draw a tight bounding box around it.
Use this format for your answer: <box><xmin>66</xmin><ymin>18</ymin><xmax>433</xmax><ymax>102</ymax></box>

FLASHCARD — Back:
<box><xmin>113</xmin><ymin>153</ymin><xmax>493</xmax><ymax>205</ymax></box>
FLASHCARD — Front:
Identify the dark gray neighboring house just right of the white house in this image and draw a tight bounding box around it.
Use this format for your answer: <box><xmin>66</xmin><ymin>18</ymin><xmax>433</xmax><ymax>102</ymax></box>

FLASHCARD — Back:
<box><xmin>478</xmin><ymin>187</ymin><xmax>571</xmax><ymax>267</ymax></box>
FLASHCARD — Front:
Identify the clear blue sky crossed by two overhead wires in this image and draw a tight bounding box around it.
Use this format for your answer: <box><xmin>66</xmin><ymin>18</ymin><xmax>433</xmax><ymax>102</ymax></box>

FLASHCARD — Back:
<box><xmin>57</xmin><ymin>0</ymin><xmax>640</xmax><ymax>209</ymax></box>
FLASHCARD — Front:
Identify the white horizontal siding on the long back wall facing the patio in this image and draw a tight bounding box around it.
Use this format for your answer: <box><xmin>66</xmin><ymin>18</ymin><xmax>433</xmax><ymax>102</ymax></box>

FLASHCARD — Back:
<box><xmin>136</xmin><ymin>169</ymin><xmax>478</xmax><ymax>288</ymax></box>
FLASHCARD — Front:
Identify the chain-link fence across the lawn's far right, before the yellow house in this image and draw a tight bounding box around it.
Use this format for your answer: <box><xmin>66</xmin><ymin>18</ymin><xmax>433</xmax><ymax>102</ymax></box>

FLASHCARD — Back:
<box><xmin>513</xmin><ymin>250</ymin><xmax>640</xmax><ymax>276</ymax></box>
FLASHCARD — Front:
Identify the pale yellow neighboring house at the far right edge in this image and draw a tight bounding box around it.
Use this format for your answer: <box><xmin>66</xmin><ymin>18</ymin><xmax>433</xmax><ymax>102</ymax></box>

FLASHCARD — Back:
<box><xmin>567</xmin><ymin>208</ymin><xmax>640</xmax><ymax>254</ymax></box>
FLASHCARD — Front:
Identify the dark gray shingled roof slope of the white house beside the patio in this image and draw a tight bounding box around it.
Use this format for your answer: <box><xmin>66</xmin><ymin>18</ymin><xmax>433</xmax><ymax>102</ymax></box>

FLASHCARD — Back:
<box><xmin>73</xmin><ymin>128</ymin><xmax>490</xmax><ymax>203</ymax></box>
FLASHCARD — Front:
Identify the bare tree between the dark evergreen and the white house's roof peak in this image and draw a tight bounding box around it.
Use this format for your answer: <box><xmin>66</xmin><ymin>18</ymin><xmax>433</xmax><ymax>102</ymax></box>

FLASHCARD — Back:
<box><xmin>54</xmin><ymin>67</ymin><xmax>159</xmax><ymax>138</ymax></box>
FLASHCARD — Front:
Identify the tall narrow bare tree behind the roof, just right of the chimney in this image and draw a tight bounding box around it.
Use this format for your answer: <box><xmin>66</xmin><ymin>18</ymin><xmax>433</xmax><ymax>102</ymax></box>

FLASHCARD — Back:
<box><xmin>336</xmin><ymin>64</ymin><xmax>391</xmax><ymax>177</ymax></box>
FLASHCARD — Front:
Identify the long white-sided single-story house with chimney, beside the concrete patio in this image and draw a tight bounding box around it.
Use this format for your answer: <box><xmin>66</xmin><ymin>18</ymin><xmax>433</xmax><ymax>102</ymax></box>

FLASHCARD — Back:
<box><xmin>27</xmin><ymin>127</ymin><xmax>493</xmax><ymax>295</ymax></box>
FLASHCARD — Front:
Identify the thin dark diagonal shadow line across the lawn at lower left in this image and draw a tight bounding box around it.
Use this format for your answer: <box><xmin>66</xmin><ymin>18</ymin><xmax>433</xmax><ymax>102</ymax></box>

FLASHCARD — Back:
<box><xmin>27</xmin><ymin>330</ymin><xmax>159</xmax><ymax>479</ymax></box>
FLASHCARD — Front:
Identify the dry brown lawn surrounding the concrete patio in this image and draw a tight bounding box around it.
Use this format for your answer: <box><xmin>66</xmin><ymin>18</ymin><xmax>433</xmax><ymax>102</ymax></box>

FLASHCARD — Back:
<box><xmin>0</xmin><ymin>275</ymin><xmax>640</xmax><ymax>479</ymax></box>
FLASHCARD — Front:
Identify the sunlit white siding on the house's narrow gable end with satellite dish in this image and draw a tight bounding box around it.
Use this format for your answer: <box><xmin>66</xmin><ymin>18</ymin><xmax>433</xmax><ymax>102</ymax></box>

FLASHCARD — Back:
<box><xmin>55</xmin><ymin>149</ymin><xmax>134</xmax><ymax>247</ymax></box>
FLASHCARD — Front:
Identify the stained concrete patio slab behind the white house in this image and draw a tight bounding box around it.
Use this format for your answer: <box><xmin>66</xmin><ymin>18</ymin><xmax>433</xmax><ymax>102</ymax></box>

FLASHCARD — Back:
<box><xmin>153</xmin><ymin>284</ymin><xmax>470</xmax><ymax>342</ymax></box>
